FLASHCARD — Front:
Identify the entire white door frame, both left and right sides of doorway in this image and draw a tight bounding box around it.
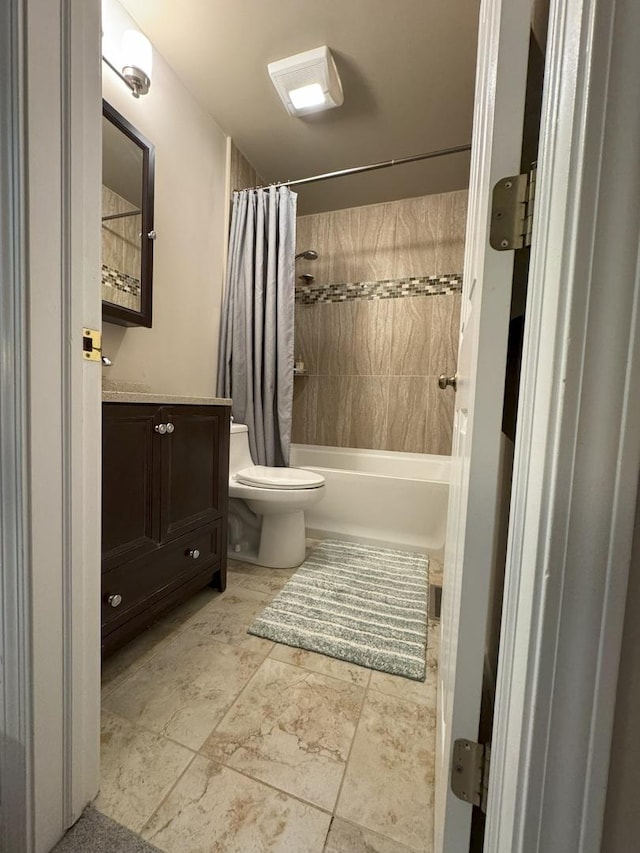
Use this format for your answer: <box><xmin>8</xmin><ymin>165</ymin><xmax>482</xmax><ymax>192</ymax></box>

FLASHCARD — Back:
<box><xmin>0</xmin><ymin>0</ymin><xmax>640</xmax><ymax>853</ymax></box>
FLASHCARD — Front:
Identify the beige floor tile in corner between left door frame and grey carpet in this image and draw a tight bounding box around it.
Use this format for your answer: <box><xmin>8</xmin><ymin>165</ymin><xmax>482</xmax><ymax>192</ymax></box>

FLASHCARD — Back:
<box><xmin>95</xmin><ymin>711</ymin><xmax>193</xmax><ymax>832</ymax></box>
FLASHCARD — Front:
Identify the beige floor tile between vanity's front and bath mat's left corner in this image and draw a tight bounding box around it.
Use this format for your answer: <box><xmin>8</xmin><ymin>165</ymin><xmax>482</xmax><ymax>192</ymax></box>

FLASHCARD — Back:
<box><xmin>185</xmin><ymin>582</ymin><xmax>273</xmax><ymax>644</ymax></box>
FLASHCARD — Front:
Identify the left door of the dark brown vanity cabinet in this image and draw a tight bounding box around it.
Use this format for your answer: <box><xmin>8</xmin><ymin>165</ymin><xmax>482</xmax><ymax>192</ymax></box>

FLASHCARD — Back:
<box><xmin>102</xmin><ymin>403</ymin><xmax>159</xmax><ymax>571</ymax></box>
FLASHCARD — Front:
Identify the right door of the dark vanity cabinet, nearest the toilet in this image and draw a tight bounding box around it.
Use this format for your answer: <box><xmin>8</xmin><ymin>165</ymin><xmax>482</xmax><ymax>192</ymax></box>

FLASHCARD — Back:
<box><xmin>159</xmin><ymin>406</ymin><xmax>229</xmax><ymax>542</ymax></box>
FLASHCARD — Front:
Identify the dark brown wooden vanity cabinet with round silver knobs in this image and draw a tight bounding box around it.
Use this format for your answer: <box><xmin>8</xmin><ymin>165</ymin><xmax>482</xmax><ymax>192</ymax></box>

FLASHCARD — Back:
<box><xmin>101</xmin><ymin>403</ymin><xmax>230</xmax><ymax>654</ymax></box>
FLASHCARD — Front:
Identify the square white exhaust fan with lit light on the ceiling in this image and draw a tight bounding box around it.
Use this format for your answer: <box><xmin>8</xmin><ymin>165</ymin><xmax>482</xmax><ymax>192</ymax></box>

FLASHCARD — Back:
<box><xmin>268</xmin><ymin>45</ymin><xmax>344</xmax><ymax>116</ymax></box>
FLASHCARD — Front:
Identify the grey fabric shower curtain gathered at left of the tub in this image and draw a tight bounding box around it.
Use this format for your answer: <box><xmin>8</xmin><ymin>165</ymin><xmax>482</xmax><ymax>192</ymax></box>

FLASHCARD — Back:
<box><xmin>218</xmin><ymin>187</ymin><xmax>297</xmax><ymax>466</ymax></box>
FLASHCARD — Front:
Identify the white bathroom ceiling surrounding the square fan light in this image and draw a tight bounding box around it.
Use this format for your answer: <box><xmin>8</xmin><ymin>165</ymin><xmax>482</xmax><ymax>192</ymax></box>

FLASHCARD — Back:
<box><xmin>122</xmin><ymin>0</ymin><xmax>479</xmax><ymax>213</ymax></box>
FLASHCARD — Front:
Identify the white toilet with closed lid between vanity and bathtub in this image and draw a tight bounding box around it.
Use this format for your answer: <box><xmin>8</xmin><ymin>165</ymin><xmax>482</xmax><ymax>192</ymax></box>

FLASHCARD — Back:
<box><xmin>229</xmin><ymin>423</ymin><xmax>324</xmax><ymax>569</ymax></box>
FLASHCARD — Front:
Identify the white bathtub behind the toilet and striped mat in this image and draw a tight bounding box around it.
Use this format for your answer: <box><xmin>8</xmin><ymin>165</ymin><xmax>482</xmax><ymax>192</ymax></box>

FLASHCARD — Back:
<box><xmin>290</xmin><ymin>444</ymin><xmax>451</xmax><ymax>553</ymax></box>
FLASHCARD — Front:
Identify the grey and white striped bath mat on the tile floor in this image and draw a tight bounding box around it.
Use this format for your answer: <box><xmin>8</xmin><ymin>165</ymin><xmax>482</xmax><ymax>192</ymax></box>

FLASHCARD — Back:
<box><xmin>249</xmin><ymin>539</ymin><xmax>429</xmax><ymax>681</ymax></box>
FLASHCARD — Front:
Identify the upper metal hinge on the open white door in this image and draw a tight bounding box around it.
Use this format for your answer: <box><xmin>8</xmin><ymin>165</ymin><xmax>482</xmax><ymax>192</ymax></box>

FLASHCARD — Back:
<box><xmin>489</xmin><ymin>164</ymin><xmax>536</xmax><ymax>252</ymax></box>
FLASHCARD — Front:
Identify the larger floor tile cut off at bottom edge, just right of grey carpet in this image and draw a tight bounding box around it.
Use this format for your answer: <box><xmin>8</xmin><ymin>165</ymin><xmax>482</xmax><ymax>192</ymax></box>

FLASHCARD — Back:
<box><xmin>142</xmin><ymin>756</ymin><xmax>328</xmax><ymax>853</ymax></box>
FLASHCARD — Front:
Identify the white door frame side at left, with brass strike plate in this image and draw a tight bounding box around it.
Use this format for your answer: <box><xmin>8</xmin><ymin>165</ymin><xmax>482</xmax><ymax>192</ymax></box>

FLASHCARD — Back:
<box><xmin>0</xmin><ymin>0</ymin><xmax>101</xmax><ymax>853</ymax></box>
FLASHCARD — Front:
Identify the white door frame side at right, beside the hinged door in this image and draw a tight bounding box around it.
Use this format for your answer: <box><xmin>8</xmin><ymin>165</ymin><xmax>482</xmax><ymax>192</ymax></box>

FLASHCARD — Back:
<box><xmin>485</xmin><ymin>0</ymin><xmax>640</xmax><ymax>853</ymax></box>
